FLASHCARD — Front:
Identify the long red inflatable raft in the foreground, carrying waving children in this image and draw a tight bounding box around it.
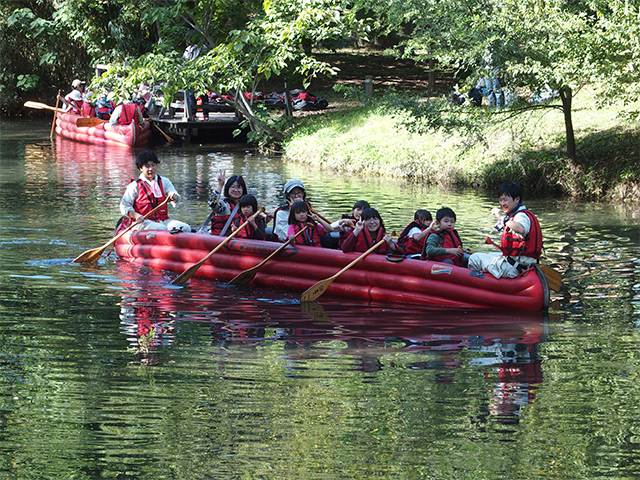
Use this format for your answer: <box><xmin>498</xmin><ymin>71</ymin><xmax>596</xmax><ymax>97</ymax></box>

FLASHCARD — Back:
<box><xmin>116</xmin><ymin>230</ymin><xmax>549</xmax><ymax>311</ymax></box>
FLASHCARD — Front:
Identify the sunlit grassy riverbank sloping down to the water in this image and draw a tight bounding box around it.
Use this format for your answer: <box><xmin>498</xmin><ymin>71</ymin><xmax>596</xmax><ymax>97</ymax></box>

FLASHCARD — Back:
<box><xmin>284</xmin><ymin>84</ymin><xmax>640</xmax><ymax>200</ymax></box>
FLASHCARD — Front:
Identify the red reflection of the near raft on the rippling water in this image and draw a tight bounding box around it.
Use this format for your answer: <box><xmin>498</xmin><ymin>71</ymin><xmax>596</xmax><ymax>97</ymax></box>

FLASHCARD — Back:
<box><xmin>121</xmin><ymin>263</ymin><xmax>548</xmax><ymax>423</ymax></box>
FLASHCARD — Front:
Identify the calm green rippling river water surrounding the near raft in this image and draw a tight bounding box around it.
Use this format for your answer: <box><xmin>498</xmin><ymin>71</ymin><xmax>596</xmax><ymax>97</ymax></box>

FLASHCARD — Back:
<box><xmin>0</xmin><ymin>117</ymin><xmax>640</xmax><ymax>479</ymax></box>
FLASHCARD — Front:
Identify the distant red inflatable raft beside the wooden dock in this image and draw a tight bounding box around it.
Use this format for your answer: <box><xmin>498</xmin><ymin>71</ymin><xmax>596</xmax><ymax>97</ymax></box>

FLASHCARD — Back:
<box><xmin>56</xmin><ymin>113</ymin><xmax>151</xmax><ymax>148</ymax></box>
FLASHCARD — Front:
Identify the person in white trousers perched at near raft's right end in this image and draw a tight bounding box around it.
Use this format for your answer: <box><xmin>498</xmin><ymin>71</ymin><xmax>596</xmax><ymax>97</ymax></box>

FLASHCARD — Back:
<box><xmin>469</xmin><ymin>182</ymin><xmax>542</xmax><ymax>278</ymax></box>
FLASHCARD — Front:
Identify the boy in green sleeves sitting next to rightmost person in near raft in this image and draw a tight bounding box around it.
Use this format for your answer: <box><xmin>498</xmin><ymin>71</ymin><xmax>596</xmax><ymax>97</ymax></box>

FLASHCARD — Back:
<box><xmin>422</xmin><ymin>208</ymin><xmax>469</xmax><ymax>267</ymax></box>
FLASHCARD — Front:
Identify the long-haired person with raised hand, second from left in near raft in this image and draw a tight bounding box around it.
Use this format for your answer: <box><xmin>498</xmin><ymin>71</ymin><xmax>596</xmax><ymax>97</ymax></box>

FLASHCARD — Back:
<box><xmin>209</xmin><ymin>169</ymin><xmax>247</xmax><ymax>235</ymax></box>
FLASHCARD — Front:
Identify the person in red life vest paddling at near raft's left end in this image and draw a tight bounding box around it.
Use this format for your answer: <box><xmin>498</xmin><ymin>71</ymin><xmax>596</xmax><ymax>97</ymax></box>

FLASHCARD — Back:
<box><xmin>120</xmin><ymin>150</ymin><xmax>191</xmax><ymax>232</ymax></box>
